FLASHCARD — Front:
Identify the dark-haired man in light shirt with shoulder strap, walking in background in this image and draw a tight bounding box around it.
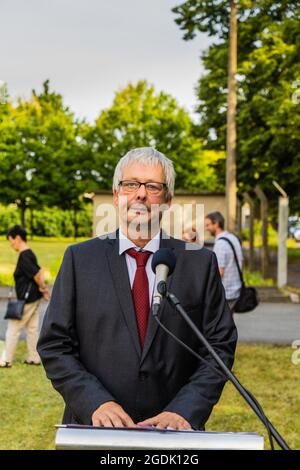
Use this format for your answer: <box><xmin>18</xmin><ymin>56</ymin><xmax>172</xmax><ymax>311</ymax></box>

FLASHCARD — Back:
<box><xmin>205</xmin><ymin>212</ymin><xmax>243</xmax><ymax>312</ymax></box>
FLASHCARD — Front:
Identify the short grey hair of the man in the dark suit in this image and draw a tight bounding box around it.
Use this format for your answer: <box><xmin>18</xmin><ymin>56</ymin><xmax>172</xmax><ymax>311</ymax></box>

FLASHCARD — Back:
<box><xmin>113</xmin><ymin>147</ymin><xmax>176</xmax><ymax>200</ymax></box>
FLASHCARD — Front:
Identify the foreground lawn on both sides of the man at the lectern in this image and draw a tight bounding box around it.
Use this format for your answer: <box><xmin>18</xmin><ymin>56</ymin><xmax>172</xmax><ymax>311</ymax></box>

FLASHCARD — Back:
<box><xmin>0</xmin><ymin>342</ymin><xmax>300</xmax><ymax>449</ymax></box>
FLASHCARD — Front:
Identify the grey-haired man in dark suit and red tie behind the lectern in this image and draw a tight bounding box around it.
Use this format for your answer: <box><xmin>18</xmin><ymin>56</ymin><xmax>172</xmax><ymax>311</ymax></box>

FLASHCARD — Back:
<box><xmin>38</xmin><ymin>148</ymin><xmax>237</xmax><ymax>429</ymax></box>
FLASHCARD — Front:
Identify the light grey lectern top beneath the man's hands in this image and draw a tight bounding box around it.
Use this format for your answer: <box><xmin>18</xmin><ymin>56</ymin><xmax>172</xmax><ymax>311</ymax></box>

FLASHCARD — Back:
<box><xmin>56</xmin><ymin>425</ymin><xmax>264</xmax><ymax>450</ymax></box>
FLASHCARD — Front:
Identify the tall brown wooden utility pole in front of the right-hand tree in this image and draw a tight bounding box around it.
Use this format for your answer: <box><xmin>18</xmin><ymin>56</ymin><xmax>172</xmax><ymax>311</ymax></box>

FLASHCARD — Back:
<box><xmin>226</xmin><ymin>0</ymin><xmax>237</xmax><ymax>232</ymax></box>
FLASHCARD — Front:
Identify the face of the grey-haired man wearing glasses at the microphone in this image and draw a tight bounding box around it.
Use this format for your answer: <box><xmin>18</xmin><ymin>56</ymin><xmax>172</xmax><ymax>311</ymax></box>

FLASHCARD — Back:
<box><xmin>114</xmin><ymin>163</ymin><xmax>171</xmax><ymax>237</ymax></box>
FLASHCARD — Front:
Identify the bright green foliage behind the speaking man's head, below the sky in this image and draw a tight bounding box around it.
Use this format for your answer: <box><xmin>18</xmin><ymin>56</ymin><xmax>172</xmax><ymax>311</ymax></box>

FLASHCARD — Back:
<box><xmin>0</xmin><ymin>81</ymin><xmax>223</xmax><ymax>232</ymax></box>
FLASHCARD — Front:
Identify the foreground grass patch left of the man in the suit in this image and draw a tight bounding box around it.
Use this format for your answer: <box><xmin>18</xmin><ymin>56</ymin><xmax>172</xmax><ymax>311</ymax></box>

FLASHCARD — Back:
<box><xmin>0</xmin><ymin>341</ymin><xmax>63</xmax><ymax>450</ymax></box>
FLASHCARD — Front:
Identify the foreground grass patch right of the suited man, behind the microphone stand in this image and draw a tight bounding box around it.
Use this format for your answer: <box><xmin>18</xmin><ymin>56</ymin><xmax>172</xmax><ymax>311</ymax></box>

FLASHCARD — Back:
<box><xmin>206</xmin><ymin>344</ymin><xmax>300</xmax><ymax>449</ymax></box>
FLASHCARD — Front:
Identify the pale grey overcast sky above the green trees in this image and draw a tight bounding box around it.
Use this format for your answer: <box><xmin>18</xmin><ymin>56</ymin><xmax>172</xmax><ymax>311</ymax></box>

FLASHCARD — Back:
<box><xmin>0</xmin><ymin>0</ymin><xmax>209</xmax><ymax>120</ymax></box>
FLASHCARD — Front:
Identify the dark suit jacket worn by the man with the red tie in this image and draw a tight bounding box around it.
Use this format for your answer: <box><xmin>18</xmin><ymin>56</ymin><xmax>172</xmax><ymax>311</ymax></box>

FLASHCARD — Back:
<box><xmin>38</xmin><ymin>231</ymin><xmax>237</xmax><ymax>429</ymax></box>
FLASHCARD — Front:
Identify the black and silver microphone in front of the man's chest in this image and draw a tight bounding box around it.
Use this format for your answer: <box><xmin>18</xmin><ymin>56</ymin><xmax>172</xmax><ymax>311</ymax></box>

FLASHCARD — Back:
<box><xmin>151</xmin><ymin>248</ymin><xmax>176</xmax><ymax>316</ymax></box>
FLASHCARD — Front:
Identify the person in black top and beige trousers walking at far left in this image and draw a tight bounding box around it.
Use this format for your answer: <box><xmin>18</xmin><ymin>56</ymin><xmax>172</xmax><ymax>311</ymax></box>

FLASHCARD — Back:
<box><xmin>0</xmin><ymin>225</ymin><xmax>49</xmax><ymax>367</ymax></box>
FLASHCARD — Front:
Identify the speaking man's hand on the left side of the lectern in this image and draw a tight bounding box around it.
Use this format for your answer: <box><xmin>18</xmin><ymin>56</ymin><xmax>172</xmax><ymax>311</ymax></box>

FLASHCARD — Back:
<box><xmin>92</xmin><ymin>401</ymin><xmax>136</xmax><ymax>428</ymax></box>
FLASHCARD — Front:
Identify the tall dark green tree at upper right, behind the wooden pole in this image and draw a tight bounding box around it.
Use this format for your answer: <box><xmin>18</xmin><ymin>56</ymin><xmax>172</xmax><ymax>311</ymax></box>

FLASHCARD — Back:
<box><xmin>174</xmin><ymin>0</ymin><xmax>300</xmax><ymax>211</ymax></box>
